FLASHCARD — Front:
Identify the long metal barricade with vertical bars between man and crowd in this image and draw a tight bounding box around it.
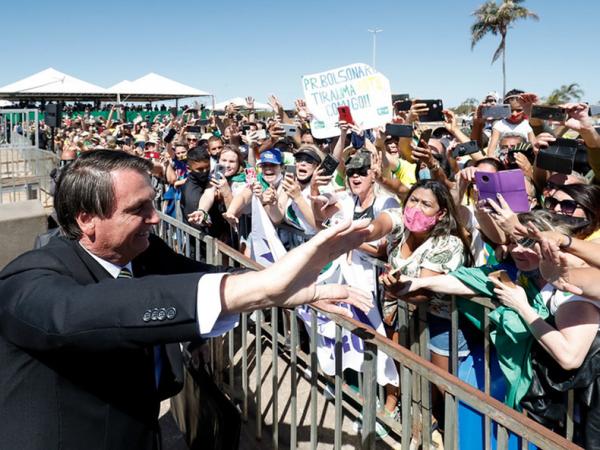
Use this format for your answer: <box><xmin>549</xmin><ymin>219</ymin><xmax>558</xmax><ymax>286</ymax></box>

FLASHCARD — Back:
<box><xmin>160</xmin><ymin>214</ymin><xmax>579</xmax><ymax>450</ymax></box>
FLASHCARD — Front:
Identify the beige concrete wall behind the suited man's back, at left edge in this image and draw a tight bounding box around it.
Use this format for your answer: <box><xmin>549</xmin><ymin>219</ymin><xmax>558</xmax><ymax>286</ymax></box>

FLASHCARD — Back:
<box><xmin>0</xmin><ymin>200</ymin><xmax>48</xmax><ymax>269</ymax></box>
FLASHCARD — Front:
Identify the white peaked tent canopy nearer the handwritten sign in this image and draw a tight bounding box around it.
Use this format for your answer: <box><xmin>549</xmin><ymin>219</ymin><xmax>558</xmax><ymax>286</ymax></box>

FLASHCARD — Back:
<box><xmin>107</xmin><ymin>73</ymin><xmax>211</xmax><ymax>101</ymax></box>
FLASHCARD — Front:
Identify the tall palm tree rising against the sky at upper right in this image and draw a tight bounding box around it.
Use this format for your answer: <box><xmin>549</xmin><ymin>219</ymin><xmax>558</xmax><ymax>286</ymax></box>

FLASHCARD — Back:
<box><xmin>471</xmin><ymin>0</ymin><xmax>539</xmax><ymax>96</ymax></box>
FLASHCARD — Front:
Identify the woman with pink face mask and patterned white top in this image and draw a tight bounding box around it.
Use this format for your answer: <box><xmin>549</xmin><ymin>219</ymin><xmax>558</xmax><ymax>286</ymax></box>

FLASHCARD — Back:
<box><xmin>367</xmin><ymin>180</ymin><xmax>473</xmax><ymax>420</ymax></box>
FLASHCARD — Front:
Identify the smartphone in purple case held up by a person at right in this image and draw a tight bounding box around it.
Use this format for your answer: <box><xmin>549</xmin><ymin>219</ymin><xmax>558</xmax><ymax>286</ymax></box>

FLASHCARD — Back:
<box><xmin>475</xmin><ymin>169</ymin><xmax>529</xmax><ymax>212</ymax></box>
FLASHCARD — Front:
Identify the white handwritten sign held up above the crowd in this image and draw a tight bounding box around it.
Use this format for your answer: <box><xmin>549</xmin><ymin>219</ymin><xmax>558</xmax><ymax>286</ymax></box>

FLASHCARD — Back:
<box><xmin>302</xmin><ymin>63</ymin><xmax>393</xmax><ymax>139</ymax></box>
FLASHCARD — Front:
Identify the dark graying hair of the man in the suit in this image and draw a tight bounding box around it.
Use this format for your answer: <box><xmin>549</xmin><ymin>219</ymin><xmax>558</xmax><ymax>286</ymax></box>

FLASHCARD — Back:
<box><xmin>54</xmin><ymin>150</ymin><xmax>152</xmax><ymax>239</ymax></box>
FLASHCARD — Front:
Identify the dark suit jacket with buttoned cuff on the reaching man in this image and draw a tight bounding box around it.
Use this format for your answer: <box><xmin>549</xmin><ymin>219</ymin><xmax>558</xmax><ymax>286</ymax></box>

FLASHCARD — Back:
<box><xmin>0</xmin><ymin>236</ymin><xmax>225</xmax><ymax>450</ymax></box>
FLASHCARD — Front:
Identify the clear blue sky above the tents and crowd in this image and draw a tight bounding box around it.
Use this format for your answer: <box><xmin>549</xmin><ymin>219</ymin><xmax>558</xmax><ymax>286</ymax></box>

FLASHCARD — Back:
<box><xmin>0</xmin><ymin>0</ymin><xmax>600</xmax><ymax>106</ymax></box>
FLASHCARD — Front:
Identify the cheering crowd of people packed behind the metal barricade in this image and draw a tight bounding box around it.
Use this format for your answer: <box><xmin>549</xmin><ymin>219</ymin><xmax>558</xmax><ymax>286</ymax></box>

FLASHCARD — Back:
<box><xmin>37</xmin><ymin>90</ymin><xmax>600</xmax><ymax>448</ymax></box>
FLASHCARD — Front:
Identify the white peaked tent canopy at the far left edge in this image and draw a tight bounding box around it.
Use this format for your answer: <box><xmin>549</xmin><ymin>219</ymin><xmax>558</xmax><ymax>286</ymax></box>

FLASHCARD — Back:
<box><xmin>0</xmin><ymin>67</ymin><xmax>110</xmax><ymax>100</ymax></box>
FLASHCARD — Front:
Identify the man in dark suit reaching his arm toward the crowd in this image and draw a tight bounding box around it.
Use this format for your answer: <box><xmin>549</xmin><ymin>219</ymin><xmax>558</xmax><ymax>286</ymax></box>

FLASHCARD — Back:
<box><xmin>0</xmin><ymin>150</ymin><xmax>371</xmax><ymax>450</ymax></box>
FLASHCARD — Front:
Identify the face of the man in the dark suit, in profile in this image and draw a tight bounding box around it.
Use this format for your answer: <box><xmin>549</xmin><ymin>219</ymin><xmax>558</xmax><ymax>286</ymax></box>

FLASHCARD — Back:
<box><xmin>83</xmin><ymin>169</ymin><xmax>159</xmax><ymax>265</ymax></box>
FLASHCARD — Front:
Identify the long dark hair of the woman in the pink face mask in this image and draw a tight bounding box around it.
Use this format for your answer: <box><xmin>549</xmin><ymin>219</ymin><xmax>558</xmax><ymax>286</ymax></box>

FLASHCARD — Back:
<box><xmin>406</xmin><ymin>180</ymin><xmax>474</xmax><ymax>266</ymax></box>
